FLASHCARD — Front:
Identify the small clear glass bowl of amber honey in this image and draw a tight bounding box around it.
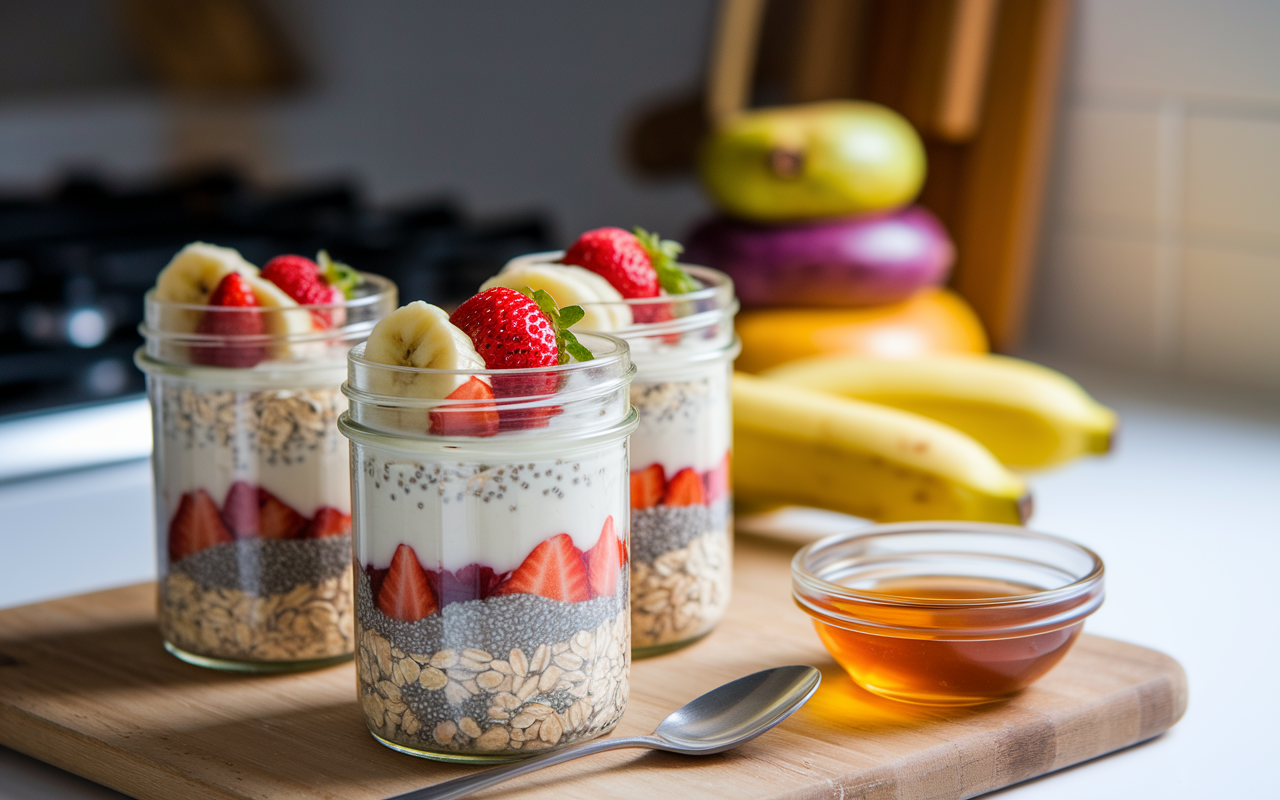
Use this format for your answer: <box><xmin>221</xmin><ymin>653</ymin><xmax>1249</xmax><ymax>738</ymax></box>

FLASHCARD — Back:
<box><xmin>791</xmin><ymin>522</ymin><xmax>1103</xmax><ymax>705</ymax></box>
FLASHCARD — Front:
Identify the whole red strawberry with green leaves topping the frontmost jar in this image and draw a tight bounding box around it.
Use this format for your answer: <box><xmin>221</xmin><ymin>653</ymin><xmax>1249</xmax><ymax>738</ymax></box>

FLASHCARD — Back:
<box><xmin>449</xmin><ymin>287</ymin><xmax>591</xmax><ymax>430</ymax></box>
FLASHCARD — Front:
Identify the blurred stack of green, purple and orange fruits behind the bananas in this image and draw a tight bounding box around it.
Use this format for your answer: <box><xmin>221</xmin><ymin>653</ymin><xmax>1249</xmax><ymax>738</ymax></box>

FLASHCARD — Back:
<box><xmin>686</xmin><ymin>102</ymin><xmax>987</xmax><ymax>371</ymax></box>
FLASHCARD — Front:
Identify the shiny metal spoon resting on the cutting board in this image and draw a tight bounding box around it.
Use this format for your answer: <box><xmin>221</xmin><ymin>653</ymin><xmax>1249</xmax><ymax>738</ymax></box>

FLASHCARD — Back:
<box><xmin>389</xmin><ymin>666</ymin><xmax>822</xmax><ymax>800</ymax></box>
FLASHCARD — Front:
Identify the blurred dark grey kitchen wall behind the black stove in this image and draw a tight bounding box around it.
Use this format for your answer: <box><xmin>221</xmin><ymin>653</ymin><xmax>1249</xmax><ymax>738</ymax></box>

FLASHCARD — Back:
<box><xmin>0</xmin><ymin>0</ymin><xmax>714</xmax><ymax>237</ymax></box>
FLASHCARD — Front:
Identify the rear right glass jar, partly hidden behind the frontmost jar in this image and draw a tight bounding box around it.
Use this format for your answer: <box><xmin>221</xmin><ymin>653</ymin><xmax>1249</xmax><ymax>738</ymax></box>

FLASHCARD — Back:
<box><xmin>501</xmin><ymin>251</ymin><xmax>741</xmax><ymax>658</ymax></box>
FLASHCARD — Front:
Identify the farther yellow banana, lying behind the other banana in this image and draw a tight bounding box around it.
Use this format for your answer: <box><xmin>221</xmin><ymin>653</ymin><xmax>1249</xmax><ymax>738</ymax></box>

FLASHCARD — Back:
<box><xmin>764</xmin><ymin>356</ymin><xmax>1116</xmax><ymax>467</ymax></box>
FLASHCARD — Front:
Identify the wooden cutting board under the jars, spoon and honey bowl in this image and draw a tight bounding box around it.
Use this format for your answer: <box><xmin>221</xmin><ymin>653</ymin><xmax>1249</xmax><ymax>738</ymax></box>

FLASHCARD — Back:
<box><xmin>0</xmin><ymin>536</ymin><xmax>1187</xmax><ymax>800</ymax></box>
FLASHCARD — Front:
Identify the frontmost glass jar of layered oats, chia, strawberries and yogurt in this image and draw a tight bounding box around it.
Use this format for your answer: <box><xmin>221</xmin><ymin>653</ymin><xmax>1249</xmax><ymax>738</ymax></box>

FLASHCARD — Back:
<box><xmin>338</xmin><ymin>334</ymin><xmax>636</xmax><ymax>762</ymax></box>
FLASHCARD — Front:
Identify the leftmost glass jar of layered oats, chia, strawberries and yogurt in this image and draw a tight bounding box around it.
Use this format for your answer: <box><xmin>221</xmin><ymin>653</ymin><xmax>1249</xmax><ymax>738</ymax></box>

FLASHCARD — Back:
<box><xmin>134</xmin><ymin>274</ymin><xmax>396</xmax><ymax>672</ymax></box>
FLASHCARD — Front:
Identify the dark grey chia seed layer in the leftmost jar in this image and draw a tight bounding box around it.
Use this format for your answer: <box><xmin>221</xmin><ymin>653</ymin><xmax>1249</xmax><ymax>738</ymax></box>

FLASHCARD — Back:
<box><xmin>169</xmin><ymin>534</ymin><xmax>351</xmax><ymax>596</ymax></box>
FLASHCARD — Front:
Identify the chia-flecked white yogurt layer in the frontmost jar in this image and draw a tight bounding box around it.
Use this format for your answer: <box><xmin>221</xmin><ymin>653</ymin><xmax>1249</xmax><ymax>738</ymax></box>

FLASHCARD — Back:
<box><xmin>353</xmin><ymin>442</ymin><xmax>630</xmax><ymax>572</ymax></box>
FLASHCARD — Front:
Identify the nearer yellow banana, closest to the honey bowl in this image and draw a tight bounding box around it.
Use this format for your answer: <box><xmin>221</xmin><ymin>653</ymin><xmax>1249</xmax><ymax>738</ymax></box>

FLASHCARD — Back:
<box><xmin>732</xmin><ymin>372</ymin><xmax>1030</xmax><ymax>522</ymax></box>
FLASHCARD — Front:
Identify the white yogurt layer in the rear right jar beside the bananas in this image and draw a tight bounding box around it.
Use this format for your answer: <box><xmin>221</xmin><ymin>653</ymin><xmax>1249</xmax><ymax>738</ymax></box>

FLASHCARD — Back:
<box><xmin>631</xmin><ymin>364</ymin><xmax>732</xmax><ymax>477</ymax></box>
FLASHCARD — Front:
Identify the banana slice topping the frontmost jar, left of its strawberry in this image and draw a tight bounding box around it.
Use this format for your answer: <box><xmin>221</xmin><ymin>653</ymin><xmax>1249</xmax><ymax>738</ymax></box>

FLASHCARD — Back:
<box><xmin>365</xmin><ymin>300</ymin><xmax>488</xmax><ymax>397</ymax></box>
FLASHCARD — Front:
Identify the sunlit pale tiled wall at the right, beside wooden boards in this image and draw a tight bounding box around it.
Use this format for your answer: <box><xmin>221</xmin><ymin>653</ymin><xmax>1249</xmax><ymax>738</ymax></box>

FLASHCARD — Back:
<box><xmin>1029</xmin><ymin>0</ymin><xmax>1280</xmax><ymax>389</ymax></box>
